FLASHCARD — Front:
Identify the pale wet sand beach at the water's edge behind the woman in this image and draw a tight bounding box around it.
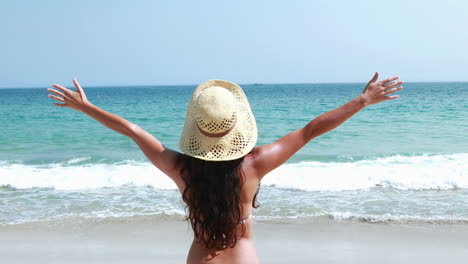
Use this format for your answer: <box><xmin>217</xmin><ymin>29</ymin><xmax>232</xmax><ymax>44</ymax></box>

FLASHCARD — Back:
<box><xmin>0</xmin><ymin>219</ymin><xmax>468</xmax><ymax>264</ymax></box>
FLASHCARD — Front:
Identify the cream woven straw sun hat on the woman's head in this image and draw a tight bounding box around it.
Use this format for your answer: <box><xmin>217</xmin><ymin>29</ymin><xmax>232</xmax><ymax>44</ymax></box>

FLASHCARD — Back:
<box><xmin>179</xmin><ymin>80</ymin><xmax>257</xmax><ymax>161</ymax></box>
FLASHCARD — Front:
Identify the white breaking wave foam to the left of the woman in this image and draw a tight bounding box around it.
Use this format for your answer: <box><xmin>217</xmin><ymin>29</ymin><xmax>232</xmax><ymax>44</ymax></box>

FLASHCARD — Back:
<box><xmin>0</xmin><ymin>158</ymin><xmax>177</xmax><ymax>190</ymax></box>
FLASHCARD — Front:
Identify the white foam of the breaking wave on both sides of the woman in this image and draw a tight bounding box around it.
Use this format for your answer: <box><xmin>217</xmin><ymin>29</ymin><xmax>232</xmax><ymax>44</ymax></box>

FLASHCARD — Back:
<box><xmin>0</xmin><ymin>153</ymin><xmax>468</xmax><ymax>191</ymax></box>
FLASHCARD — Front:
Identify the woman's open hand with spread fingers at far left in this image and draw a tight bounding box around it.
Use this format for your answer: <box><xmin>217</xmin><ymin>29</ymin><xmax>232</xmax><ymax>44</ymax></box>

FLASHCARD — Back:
<box><xmin>47</xmin><ymin>79</ymin><xmax>89</xmax><ymax>112</ymax></box>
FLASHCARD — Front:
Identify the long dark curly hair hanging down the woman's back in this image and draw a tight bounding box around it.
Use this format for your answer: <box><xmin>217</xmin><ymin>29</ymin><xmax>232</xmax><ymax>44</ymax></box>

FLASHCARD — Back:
<box><xmin>178</xmin><ymin>154</ymin><xmax>259</xmax><ymax>249</ymax></box>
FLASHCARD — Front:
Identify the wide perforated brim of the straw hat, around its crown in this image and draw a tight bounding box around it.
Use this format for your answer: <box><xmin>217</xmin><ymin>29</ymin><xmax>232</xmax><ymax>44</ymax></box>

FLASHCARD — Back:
<box><xmin>179</xmin><ymin>80</ymin><xmax>257</xmax><ymax>161</ymax></box>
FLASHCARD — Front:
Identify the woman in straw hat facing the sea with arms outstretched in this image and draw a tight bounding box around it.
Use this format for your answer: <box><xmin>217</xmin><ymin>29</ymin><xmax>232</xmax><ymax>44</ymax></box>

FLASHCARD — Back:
<box><xmin>48</xmin><ymin>73</ymin><xmax>403</xmax><ymax>264</ymax></box>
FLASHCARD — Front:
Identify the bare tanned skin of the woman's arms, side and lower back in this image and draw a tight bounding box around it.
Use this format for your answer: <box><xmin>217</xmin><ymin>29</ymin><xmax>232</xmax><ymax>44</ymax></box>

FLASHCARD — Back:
<box><xmin>47</xmin><ymin>73</ymin><xmax>403</xmax><ymax>264</ymax></box>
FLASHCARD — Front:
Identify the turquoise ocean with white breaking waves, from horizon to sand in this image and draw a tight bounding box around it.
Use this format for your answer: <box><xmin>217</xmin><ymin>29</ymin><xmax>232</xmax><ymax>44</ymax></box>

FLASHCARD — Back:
<box><xmin>0</xmin><ymin>83</ymin><xmax>468</xmax><ymax>225</ymax></box>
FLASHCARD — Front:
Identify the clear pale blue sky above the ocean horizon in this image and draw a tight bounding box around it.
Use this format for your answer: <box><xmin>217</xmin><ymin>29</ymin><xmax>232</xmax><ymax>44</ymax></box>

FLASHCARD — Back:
<box><xmin>0</xmin><ymin>0</ymin><xmax>468</xmax><ymax>88</ymax></box>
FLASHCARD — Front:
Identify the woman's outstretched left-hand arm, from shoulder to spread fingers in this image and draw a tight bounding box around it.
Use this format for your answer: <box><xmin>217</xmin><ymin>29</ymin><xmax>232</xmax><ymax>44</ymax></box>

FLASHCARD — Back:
<box><xmin>47</xmin><ymin>79</ymin><xmax>183</xmax><ymax>188</ymax></box>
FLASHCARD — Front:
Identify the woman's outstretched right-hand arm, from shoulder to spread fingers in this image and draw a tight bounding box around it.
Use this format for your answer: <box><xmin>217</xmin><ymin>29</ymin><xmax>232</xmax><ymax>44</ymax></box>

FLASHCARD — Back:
<box><xmin>253</xmin><ymin>73</ymin><xmax>403</xmax><ymax>179</ymax></box>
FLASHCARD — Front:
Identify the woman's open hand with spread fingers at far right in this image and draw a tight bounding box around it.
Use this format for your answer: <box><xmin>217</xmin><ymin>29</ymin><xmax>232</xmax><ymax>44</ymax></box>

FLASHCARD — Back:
<box><xmin>361</xmin><ymin>72</ymin><xmax>403</xmax><ymax>105</ymax></box>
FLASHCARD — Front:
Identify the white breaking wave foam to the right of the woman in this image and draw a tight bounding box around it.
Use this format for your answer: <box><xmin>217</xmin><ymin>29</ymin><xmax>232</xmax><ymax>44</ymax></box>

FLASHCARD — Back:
<box><xmin>263</xmin><ymin>153</ymin><xmax>468</xmax><ymax>191</ymax></box>
